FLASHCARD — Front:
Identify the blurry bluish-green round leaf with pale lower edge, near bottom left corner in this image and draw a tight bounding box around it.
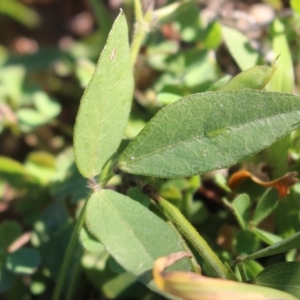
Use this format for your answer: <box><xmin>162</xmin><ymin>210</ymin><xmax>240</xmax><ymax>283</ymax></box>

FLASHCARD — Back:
<box><xmin>6</xmin><ymin>248</ymin><xmax>41</xmax><ymax>274</ymax></box>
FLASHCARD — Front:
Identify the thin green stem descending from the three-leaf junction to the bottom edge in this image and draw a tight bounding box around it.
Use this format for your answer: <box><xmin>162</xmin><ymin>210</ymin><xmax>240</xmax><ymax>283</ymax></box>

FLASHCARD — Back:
<box><xmin>52</xmin><ymin>201</ymin><xmax>87</xmax><ymax>300</ymax></box>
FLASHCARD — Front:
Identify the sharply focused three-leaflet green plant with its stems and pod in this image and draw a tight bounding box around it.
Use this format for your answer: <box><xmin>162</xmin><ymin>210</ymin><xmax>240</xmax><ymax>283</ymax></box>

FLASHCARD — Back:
<box><xmin>54</xmin><ymin>6</ymin><xmax>300</xmax><ymax>299</ymax></box>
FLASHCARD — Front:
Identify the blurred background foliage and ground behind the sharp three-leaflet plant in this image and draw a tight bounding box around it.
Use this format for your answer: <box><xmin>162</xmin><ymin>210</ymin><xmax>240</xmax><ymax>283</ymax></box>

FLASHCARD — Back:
<box><xmin>0</xmin><ymin>0</ymin><xmax>300</xmax><ymax>299</ymax></box>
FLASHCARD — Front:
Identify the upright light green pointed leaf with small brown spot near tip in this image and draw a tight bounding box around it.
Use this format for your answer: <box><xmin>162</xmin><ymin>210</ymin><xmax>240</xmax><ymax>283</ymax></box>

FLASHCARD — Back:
<box><xmin>74</xmin><ymin>12</ymin><xmax>134</xmax><ymax>177</ymax></box>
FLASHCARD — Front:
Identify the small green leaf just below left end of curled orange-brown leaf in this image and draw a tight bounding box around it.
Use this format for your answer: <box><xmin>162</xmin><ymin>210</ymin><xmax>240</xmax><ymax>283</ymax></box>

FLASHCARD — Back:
<box><xmin>231</xmin><ymin>194</ymin><xmax>250</xmax><ymax>229</ymax></box>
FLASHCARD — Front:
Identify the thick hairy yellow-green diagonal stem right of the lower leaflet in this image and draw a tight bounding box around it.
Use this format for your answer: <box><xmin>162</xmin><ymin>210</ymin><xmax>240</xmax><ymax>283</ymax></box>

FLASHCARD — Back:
<box><xmin>157</xmin><ymin>197</ymin><xmax>237</xmax><ymax>280</ymax></box>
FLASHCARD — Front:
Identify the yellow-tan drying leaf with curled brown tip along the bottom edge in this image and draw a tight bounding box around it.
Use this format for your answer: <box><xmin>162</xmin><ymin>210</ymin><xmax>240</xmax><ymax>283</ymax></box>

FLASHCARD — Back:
<box><xmin>153</xmin><ymin>252</ymin><xmax>296</xmax><ymax>300</ymax></box>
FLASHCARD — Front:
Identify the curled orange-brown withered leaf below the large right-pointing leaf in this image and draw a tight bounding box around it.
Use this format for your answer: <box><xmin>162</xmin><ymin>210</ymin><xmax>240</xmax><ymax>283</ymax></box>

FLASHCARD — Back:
<box><xmin>228</xmin><ymin>170</ymin><xmax>299</xmax><ymax>198</ymax></box>
